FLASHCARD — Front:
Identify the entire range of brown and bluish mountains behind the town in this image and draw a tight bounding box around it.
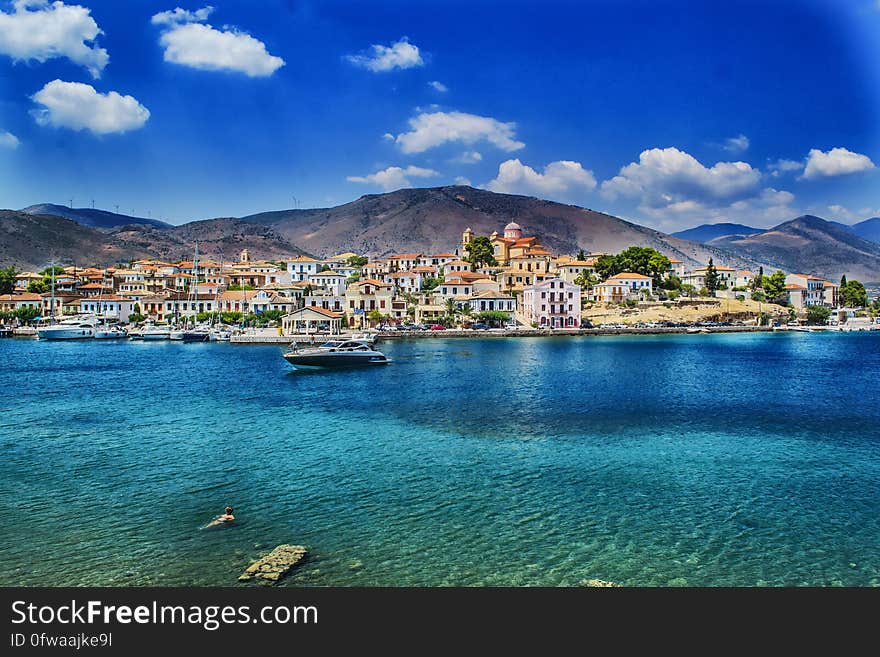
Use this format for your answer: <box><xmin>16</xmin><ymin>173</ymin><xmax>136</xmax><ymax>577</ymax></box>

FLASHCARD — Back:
<box><xmin>0</xmin><ymin>186</ymin><xmax>880</xmax><ymax>281</ymax></box>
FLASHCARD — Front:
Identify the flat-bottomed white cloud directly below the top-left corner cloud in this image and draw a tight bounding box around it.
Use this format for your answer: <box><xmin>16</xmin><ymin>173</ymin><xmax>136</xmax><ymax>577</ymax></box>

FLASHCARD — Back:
<box><xmin>31</xmin><ymin>80</ymin><xmax>150</xmax><ymax>135</ymax></box>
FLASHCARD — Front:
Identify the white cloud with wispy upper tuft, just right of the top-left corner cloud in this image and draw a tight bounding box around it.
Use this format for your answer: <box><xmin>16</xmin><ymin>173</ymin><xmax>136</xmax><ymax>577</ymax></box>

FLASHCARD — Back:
<box><xmin>152</xmin><ymin>7</ymin><xmax>285</xmax><ymax>78</ymax></box>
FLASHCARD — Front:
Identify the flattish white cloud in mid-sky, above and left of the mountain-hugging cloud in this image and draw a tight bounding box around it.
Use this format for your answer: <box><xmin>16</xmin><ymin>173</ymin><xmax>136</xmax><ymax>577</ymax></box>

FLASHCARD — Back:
<box><xmin>395</xmin><ymin>112</ymin><xmax>525</xmax><ymax>153</ymax></box>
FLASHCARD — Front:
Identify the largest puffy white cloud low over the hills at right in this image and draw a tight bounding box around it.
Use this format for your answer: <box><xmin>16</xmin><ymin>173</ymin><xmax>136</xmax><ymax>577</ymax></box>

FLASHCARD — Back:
<box><xmin>602</xmin><ymin>148</ymin><xmax>761</xmax><ymax>208</ymax></box>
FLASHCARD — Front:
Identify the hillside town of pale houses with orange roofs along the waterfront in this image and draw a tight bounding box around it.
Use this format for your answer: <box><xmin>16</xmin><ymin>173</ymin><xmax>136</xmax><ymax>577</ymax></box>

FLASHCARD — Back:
<box><xmin>0</xmin><ymin>222</ymin><xmax>878</xmax><ymax>335</ymax></box>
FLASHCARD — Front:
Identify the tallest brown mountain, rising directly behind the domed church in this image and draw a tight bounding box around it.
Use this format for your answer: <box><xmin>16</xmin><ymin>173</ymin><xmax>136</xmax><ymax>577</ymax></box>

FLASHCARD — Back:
<box><xmin>244</xmin><ymin>186</ymin><xmax>749</xmax><ymax>266</ymax></box>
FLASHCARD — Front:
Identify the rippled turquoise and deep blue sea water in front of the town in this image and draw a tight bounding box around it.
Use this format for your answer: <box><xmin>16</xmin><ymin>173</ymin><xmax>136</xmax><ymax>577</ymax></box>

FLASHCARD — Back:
<box><xmin>0</xmin><ymin>333</ymin><xmax>880</xmax><ymax>586</ymax></box>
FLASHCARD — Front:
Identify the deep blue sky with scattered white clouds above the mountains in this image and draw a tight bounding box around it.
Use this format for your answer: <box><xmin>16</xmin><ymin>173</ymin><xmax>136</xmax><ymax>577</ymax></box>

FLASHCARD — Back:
<box><xmin>0</xmin><ymin>0</ymin><xmax>880</xmax><ymax>231</ymax></box>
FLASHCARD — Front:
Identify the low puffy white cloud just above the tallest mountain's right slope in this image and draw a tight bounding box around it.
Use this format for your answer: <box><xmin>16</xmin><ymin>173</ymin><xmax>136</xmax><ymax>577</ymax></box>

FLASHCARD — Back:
<box><xmin>485</xmin><ymin>160</ymin><xmax>596</xmax><ymax>199</ymax></box>
